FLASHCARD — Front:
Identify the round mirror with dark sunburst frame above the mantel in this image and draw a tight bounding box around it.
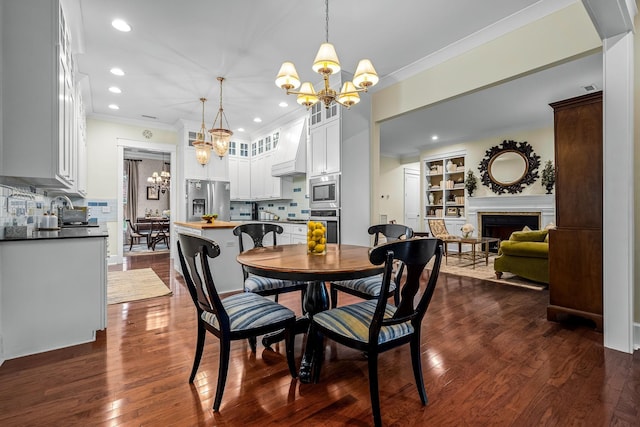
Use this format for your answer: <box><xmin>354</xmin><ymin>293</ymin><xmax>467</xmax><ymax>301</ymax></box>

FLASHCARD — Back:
<box><xmin>479</xmin><ymin>140</ymin><xmax>540</xmax><ymax>194</ymax></box>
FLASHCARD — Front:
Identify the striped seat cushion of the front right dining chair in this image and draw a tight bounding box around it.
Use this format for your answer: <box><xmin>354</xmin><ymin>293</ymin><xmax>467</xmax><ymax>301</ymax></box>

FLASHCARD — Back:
<box><xmin>313</xmin><ymin>300</ymin><xmax>413</xmax><ymax>344</ymax></box>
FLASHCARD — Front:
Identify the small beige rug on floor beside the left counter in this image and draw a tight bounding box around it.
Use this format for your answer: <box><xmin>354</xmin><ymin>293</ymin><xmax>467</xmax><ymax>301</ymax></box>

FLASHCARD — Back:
<box><xmin>107</xmin><ymin>268</ymin><xmax>172</xmax><ymax>304</ymax></box>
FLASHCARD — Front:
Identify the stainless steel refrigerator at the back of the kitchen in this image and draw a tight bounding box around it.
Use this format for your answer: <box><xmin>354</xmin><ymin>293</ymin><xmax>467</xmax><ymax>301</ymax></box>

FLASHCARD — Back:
<box><xmin>187</xmin><ymin>179</ymin><xmax>231</xmax><ymax>221</ymax></box>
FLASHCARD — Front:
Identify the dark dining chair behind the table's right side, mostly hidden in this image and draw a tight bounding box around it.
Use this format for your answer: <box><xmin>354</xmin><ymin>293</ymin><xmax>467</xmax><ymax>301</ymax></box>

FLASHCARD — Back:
<box><xmin>330</xmin><ymin>224</ymin><xmax>413</xmax><ymax>308</ymax></box>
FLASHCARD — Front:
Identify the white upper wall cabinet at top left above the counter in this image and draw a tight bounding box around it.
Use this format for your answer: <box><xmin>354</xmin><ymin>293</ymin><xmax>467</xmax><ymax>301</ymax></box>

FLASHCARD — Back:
<box><xmin>0</xmin><ymin>0</ymin><xmax>78</xmax><ymax>189</ymax></box>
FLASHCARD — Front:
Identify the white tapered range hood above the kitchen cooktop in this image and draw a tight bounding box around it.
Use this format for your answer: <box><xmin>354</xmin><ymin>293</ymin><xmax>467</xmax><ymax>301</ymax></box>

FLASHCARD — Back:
<box><xmin>271</xmin><ymin>118</ymin><xmax>307</xmax><ymax>177</ymax></box>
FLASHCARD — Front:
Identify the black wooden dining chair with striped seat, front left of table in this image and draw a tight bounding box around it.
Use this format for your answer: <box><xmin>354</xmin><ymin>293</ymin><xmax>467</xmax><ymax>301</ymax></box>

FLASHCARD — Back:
<box><xmin>178</xmin><ymin>234</ymin><xmax>297</xmax><ymax>411</ymax></box>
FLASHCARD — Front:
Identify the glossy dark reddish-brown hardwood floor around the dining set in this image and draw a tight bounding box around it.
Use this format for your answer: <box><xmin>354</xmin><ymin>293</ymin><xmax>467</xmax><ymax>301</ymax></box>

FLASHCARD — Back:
<box><xmin>0</xmin><ymin>254</ymin><xmax>640</xmax><ymax>426</ymax></box>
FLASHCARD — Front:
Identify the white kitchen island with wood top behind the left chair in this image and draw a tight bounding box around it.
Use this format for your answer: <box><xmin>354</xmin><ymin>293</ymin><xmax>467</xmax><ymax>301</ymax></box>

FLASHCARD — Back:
<box><xmin>172</xmin><ymin>220</ymin><xmax>245</xmax><ymax>293</ymax></box>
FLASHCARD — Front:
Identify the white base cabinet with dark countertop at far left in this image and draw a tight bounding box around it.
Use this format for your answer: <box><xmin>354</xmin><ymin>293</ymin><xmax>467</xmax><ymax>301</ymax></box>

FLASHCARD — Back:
<box><xmin>0</xmin><ymin>227</ymin><xmax>109</xmax><ymax>363</ymax></box>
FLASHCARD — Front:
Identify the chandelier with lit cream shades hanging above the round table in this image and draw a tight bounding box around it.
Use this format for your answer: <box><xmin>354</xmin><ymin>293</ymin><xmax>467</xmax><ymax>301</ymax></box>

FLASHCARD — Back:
<box><xmin>276</xmin><ymin>0</ymin><xmax>378</xmax><ymax>109</ymax></box>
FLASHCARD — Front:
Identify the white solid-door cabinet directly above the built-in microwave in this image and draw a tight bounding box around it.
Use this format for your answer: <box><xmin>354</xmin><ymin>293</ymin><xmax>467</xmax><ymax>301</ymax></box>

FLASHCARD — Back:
<box><xmin>307</xmin><ymin>120</ymin><xmax>340</xmax><ymax>177</ymax></box>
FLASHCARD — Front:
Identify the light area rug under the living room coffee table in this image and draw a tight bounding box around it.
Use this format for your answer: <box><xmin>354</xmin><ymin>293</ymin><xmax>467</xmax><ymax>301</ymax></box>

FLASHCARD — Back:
<box><xmin>430</xmin><ymin>254</ymin><xmax>547</xmax><ymax>291</ymax></box>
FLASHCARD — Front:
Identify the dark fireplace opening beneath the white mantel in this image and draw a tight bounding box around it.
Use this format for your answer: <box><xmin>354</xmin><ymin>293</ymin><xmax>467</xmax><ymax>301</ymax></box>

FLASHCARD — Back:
<box><xmin>478</xmin><ymin>212</ymin><xmax>540</xmax><ymax>252</ymax></box>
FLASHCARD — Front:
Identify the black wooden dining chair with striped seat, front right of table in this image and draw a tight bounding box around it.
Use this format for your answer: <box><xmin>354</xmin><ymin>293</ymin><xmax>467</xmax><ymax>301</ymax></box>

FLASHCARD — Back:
<box><xmin>307</xmin><ymin>238</ymin><xmax>443</xmax><ymax>426</ymax></box>
